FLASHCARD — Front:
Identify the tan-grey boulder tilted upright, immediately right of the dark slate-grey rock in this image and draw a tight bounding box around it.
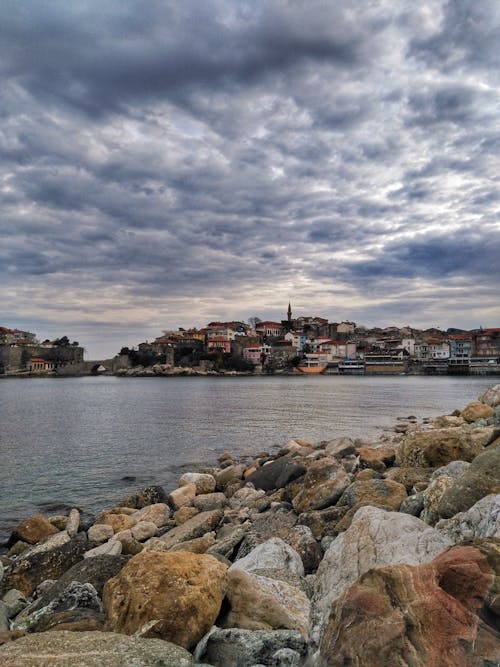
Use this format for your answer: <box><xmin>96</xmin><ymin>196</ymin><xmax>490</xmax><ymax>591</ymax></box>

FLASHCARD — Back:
<box><xmin>292</xmin><ymin>458</ymin><xmax>351</xmax><ymax>513</ymax></box>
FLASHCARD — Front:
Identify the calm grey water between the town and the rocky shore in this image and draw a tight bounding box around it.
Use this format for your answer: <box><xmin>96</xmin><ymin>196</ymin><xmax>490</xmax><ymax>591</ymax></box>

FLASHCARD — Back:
<box><xmin>0</xmin><ymin>377</ymin><xmax>492</xmax><ymax>543</ymax></box>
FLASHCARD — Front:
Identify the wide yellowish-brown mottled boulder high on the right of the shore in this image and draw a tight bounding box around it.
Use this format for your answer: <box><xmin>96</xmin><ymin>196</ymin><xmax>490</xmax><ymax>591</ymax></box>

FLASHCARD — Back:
<box><xmin>396</xmin><ymin>425</ymin><xmax>483</xmax><ymax>468</ymax></box>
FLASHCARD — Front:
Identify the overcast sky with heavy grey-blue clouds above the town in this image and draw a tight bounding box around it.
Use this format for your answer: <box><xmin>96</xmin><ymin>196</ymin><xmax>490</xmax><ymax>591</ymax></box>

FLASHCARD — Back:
<box><xmin>0</xmin><ymin>0</ymin><xmax>500</xmax><ymax>359</ymax></box>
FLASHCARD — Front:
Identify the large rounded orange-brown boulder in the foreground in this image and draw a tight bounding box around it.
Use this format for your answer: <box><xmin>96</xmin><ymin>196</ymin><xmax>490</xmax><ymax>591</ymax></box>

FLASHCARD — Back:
<box><xmin>103</xmin><ymin>551</ymin><xmax>227</xmax><ymax>649</ymax></box>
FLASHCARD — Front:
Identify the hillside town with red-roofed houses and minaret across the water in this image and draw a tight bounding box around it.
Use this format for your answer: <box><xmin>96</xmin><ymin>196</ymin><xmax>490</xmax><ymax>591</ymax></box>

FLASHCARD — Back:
<box><xmin>0</xmin><ymin>304</ymin><xmax>500</xmax><ymax>375</ymax></box>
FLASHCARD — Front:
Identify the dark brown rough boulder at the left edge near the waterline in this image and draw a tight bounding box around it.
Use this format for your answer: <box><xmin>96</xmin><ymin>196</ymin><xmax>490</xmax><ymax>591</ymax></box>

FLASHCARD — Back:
<box><xmin>2</xmin><ymin>533</ymin><xmax>87</xmax><ymax>596</ymax></box>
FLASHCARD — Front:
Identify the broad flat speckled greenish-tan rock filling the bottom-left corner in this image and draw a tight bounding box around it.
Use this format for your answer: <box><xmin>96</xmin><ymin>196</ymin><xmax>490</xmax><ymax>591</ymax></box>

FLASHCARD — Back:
<box><xmin>0</xmin><ymin>631</ymin><xmax>193</xmax><ymax>667</ymax></box>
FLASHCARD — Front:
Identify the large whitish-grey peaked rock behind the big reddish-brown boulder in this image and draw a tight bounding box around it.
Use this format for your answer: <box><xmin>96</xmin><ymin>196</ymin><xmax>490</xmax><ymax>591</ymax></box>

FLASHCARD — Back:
<box><xmin>311</xmin><ymin>506</ymin><xmax>453</xmax><ymax>643</ymax></box>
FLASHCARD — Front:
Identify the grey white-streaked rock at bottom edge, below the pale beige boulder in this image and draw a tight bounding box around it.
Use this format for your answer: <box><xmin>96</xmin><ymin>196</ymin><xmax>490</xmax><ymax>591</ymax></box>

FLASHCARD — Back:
<box><xmin>200</xmin><ymin>628</ymin><xmax>307</xmax><ymax>667</ymax></box>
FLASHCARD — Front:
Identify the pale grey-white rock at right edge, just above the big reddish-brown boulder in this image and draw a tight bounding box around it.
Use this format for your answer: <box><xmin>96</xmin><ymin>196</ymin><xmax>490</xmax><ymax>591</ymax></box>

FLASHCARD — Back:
<box><xmin>436</xmin><ymin>494</ymin><xmax>500</xmax><ymax>544</ymax></box>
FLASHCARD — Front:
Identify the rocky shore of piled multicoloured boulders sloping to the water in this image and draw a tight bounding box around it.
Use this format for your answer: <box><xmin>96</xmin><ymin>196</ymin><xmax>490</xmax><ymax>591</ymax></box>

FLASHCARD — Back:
<box><xmin>0</xmin><ymin>385</ymin><xmax>500</xmax><ymax>667</ymax></box>
